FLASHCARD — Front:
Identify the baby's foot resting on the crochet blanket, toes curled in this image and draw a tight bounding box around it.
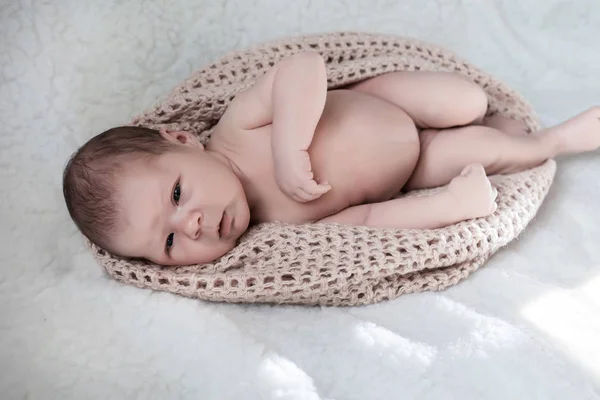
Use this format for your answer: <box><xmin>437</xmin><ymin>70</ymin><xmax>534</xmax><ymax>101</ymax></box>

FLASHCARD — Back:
<box><xmin>448</xmin><ymin>164</ymin><xmax>498</xmax><ymax>220</ymax></box>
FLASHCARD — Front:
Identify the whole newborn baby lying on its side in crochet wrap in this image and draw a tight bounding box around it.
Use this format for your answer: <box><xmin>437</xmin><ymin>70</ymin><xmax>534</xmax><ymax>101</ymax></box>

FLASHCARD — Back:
<box><xmin>63</xmin><ymin>52</ymin><xmax>600</xmax><ymax>265</ymax></box>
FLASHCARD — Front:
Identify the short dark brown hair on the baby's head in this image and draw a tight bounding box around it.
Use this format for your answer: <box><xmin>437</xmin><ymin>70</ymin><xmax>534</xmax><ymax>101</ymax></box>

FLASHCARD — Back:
<box><xmin>63</xmin><ymin>126</ymin><xmax>174</xmax><ymax>251</ymax></box>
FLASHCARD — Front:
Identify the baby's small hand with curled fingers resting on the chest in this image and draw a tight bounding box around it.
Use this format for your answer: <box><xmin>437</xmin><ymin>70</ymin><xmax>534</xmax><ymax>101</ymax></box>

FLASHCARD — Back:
<box><xmin>275</xmin><ymin>150</ymin><xmax>331</xmax><ymax>203</ymax></box>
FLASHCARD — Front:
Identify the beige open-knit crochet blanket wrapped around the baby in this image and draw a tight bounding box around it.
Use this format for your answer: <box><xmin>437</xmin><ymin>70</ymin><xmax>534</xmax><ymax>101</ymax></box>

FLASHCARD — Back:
<box><xmin>90</xmin><ymin>33</ymin><xmax>556</xmax><ymax>306</ymax></box>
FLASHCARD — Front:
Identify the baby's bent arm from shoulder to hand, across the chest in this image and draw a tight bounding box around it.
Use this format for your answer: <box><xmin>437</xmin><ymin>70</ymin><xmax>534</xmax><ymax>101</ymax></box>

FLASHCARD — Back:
<box><xmin>228</xmin><ymin>52</ymin><xmax>330</xmax><ymax>202</ymax></box>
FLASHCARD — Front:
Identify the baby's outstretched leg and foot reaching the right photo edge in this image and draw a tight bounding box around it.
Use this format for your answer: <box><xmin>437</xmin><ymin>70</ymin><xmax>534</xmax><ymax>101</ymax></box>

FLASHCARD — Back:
<box><xmin>405</xmin><ymin>107</ymin><xmax>600</xmax><ymax>190</ymax></box>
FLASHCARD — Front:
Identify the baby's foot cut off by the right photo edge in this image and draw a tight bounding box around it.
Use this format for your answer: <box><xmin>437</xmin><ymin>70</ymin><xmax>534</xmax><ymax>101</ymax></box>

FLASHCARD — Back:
<box><xmin>540</xmin><ymin>106</ymin><xmax>600</xmax><ymax>154</ymax></box>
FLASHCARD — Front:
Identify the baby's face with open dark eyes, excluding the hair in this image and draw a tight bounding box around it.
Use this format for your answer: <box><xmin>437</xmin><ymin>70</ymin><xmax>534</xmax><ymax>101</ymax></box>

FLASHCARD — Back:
<box><xmin>114</xmin><ymin>144</ymin><xmax>250</xmax><ymax>265</ymax></box>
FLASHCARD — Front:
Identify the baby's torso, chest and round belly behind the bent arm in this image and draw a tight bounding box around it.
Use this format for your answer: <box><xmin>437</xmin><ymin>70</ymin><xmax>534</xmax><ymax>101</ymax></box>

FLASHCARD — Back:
<box><xmin>212</xmin><ymin>90</ymin><xmax>419</xmax><ymax>223</ymax></box>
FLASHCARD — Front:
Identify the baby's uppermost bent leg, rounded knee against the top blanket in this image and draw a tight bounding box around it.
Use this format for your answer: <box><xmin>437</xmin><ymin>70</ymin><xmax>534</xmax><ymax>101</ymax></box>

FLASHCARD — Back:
<box><xmin>351</xmin><ymin>71</ymin><xmax>488</xmax><ymax>129</ymax></box>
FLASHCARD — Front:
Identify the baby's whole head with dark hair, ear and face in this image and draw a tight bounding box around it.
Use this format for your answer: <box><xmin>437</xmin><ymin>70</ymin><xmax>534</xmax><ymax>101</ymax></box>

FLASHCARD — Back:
<box><xmin>63</xmin><ymin>127</ymin><xmax>250</xmax><ymax>265</ymax></box>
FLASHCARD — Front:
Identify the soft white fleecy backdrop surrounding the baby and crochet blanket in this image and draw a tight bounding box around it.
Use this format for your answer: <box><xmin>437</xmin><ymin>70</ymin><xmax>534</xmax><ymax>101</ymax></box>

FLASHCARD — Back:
<box><xmin>0</xmin><ymin>0</ymin><xmax>600</xmax><ymax>400</ymax></box>
